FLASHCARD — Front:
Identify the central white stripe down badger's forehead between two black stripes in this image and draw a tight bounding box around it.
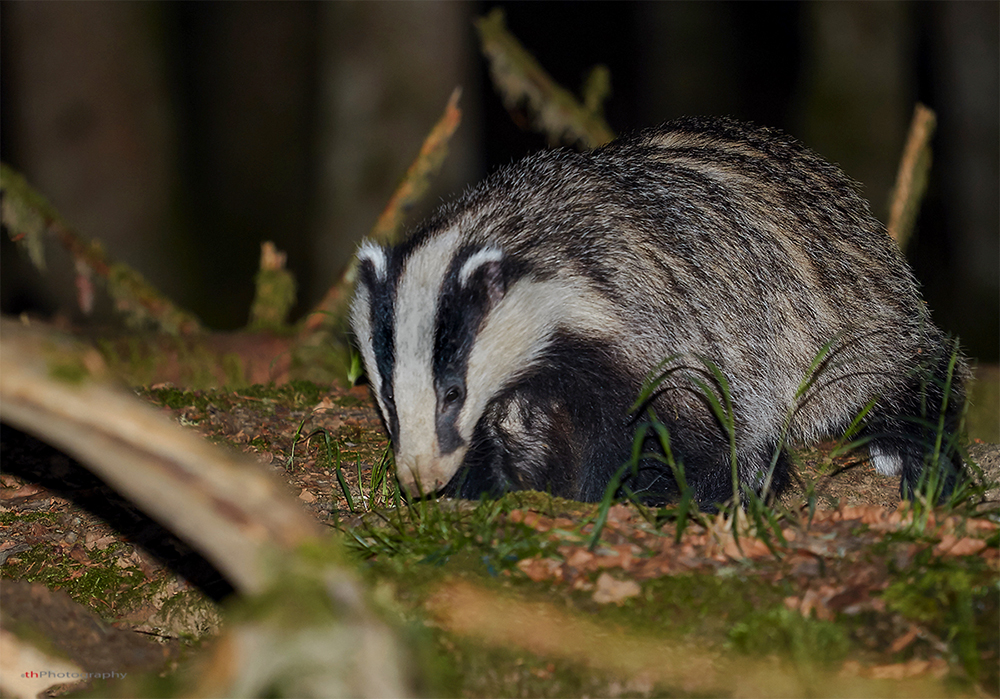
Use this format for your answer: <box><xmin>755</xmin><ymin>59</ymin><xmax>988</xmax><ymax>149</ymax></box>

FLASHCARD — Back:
<box><xmin>393</xmin><ymin>230</ymin><xmax>459</xmax><ymax>464</ymax></box>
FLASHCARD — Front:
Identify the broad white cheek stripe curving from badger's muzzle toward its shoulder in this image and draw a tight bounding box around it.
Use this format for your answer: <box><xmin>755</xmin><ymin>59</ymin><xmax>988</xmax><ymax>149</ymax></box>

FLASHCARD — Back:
<box><xmin>458</xmin><ymin>279</ymin><xmax>624</xmax><ymax>439</ymax></box>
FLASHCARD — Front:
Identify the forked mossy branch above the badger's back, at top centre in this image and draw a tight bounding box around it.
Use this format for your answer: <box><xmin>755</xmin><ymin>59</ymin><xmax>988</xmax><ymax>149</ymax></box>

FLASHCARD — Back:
<box><xmin>476</xmin><ymin>8</ymin><xmax>615</xmax><ymax>149</ymax></box>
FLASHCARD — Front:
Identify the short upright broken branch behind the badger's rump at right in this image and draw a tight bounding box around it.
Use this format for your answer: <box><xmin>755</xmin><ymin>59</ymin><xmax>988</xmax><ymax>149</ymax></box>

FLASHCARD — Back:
<box><xmin>888</xmin><ymin>102</ymin><xmax>937</xmax><ymax>250</ymax></box>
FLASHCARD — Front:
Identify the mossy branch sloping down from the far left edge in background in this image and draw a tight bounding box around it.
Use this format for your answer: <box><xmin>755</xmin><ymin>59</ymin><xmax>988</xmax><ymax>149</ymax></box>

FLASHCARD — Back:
<box><xmin>0</xmin><ymin>164</ymin><xmax>201</xmax><ymax>335</ymax></box>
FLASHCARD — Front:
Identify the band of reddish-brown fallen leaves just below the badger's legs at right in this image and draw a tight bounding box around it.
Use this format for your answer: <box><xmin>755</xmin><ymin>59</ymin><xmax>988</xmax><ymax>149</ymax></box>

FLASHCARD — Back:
<box><xmin>508</xmin><ymin>505</ymin><xmax>998</xmax><ymax>600</ymax></box>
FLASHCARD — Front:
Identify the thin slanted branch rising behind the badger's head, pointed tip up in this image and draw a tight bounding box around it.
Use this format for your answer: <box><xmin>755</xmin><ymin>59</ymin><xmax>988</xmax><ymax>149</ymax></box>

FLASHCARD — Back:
<box><xmin>300</xmin><ymin>88</ymin><xmax>462</xmax><ymax>339</ymax></box>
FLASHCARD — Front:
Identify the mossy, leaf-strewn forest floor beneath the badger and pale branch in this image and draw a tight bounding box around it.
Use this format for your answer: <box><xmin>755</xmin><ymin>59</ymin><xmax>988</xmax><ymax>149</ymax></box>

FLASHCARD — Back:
<box><xmin>0</xmin><ymin>382</ymin><xmax>1000</xmax><ymax>696</ymax></box>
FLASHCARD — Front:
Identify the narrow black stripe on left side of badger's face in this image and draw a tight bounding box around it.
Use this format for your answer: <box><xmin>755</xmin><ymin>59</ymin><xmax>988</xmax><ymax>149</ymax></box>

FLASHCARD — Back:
<box><xmin>358</xmin><ymin>260</ymin><xmax>399</xmax><ymax>443</ymax></box>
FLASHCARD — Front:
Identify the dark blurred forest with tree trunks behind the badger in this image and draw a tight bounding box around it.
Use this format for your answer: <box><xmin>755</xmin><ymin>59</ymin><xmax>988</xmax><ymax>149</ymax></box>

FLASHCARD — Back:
<box><xmin>0</xmin><ymin>2</ymin><xmax>1000</xmax><ymax>361</ymax></box>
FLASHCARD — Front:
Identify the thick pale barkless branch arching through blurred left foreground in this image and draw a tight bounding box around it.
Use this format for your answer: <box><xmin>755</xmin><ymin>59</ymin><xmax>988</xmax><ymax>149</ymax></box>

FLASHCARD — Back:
<box><xmin>0</xmin><ymin>320</ymin><xmax>319</xmax><ymax>592</ymax></box>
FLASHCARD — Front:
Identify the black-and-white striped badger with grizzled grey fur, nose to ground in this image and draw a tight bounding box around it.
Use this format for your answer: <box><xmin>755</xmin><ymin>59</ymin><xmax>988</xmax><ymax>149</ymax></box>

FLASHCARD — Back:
<box><xmin>350</xmin><ymin>118</ymin><xmax>968</xmax><ymax>508</ymax></box>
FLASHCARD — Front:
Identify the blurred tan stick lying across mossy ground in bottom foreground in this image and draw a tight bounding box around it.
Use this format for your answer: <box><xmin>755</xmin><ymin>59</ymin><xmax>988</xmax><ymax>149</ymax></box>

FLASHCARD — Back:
<box><xmin>424</xmin><ymin>572</ymin><xmax>948</xmax><ymax>697</ymax></box>
